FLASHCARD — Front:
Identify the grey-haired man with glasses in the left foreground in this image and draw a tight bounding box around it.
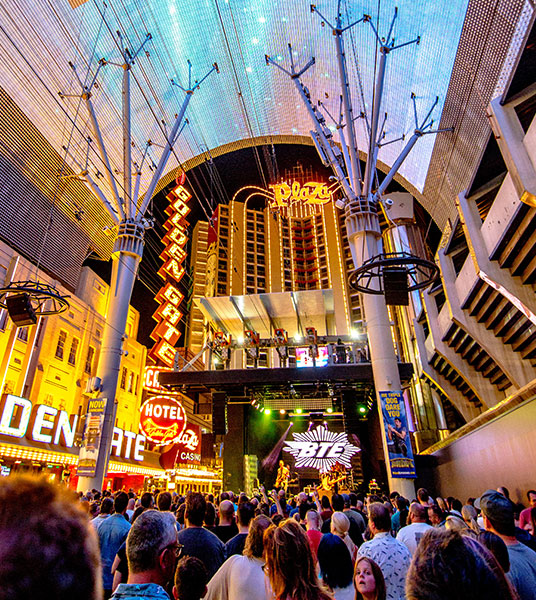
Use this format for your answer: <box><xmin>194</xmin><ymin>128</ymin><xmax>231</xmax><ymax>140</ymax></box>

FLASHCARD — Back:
<box><xmin>112</xmin><ymin>510</ymin><xmax>180</xmax><ymax>600</ymax></box>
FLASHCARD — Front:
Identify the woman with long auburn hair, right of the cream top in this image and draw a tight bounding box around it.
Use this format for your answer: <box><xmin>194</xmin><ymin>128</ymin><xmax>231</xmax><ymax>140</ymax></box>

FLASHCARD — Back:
<box><xmin>262</xmin><ymin>519</ymin><xmax>333</xmax><ymax>600</ymax></box>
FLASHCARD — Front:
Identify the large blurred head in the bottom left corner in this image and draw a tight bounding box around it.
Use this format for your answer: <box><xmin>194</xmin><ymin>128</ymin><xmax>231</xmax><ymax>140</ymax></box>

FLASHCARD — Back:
<box><xmin>0</xmin><ymin>476</ymin><xmax>101</xmax><ymax>600</ymax></box>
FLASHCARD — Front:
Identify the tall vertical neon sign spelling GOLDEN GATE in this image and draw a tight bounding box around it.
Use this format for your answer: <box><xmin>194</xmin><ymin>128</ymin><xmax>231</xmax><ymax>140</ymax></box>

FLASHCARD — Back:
<box><xmin>149</xmin><ymin>185</ymin><xmax>192</xmax><ymax>367</ymax></box>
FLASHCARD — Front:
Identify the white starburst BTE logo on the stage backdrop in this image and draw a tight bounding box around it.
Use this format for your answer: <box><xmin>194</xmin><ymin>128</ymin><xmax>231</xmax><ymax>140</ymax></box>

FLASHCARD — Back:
<box><xmin>283</xmin><ymin>425</ymin><xmax>360</xmax><ymax>473</ymax></box>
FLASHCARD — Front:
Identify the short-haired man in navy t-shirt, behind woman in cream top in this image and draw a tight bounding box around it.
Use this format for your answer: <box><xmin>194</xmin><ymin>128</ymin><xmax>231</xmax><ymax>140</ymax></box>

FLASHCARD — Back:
<box><xmin>178</xmin><ymin>492</ymin><xmax>225</xmax><ymax>579</ymax></box>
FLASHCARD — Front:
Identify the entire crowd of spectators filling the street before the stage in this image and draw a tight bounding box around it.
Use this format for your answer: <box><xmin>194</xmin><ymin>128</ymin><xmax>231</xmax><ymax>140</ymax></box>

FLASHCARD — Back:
<box><xmin>0</xmin><ymin>476</ymin><xmax>536</xmax><ymax>600</ymax></box>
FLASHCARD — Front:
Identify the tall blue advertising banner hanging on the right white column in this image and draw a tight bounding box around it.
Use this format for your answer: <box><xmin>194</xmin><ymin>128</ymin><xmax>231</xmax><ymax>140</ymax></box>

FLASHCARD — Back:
<box><xmin>380</xmin><ymin>391</ymin><xmax>417</xmax><ymax>478</ymax></box>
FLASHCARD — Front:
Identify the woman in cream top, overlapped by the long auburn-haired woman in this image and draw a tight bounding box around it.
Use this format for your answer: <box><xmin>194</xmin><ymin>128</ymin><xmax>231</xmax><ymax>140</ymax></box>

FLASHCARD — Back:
<box><xmin>205</xmin><ymin>515</ymin><xmax>272</xmax><ymax>600</ymax></box>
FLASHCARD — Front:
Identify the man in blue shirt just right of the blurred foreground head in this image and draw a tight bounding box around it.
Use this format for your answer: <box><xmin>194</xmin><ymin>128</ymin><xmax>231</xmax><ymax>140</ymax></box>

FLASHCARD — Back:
<box><xmin>97</xmin><ymin>492</ymin><xmax>130</xmax><ymax>599</ymax></box>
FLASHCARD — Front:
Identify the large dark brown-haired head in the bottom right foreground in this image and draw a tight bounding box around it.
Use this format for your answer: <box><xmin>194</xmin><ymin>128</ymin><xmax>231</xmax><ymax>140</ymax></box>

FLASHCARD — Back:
<box><xmin>406</xmin><ymin>529</ymin><xmax>517</xmax><ymax>600</ymax></box>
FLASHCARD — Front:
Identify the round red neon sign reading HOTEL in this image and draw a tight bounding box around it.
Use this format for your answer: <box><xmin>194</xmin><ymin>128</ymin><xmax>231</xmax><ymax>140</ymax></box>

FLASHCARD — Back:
<box><xmin>140</xmin><ymin>396</ymin><xmax>186</xmax><ymax>446</ymax></box>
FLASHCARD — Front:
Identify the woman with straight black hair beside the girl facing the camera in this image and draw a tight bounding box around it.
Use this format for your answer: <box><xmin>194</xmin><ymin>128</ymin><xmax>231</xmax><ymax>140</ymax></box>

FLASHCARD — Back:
<box><xmin>318</xmin><ymin>533</ymin><xmax>355</xmax><ymax>600</ymax></box>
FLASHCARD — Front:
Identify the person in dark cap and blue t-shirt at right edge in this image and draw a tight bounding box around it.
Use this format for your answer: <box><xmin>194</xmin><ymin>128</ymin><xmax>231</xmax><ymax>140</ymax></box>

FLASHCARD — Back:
<box><xmin>475</xmin><ymin>490</ymin><xmax>536</xmax><ymax>600</ymax></box>
